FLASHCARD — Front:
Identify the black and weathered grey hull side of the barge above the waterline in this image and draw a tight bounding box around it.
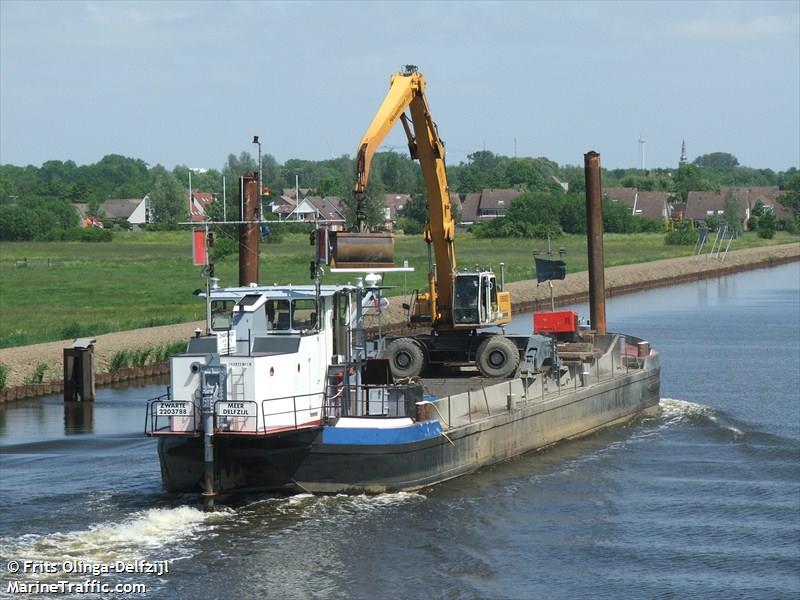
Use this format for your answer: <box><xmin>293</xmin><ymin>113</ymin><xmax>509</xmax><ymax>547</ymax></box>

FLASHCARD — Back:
<box><xmin>158</xmin><ymin>367</ymin><xmax>660</xmax><ymax>494</ymax></box>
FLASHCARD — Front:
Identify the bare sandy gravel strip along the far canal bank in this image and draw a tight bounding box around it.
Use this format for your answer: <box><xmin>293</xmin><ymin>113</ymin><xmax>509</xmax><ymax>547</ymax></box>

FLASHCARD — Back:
<box><xmin>0</xmin><ymin>243</ymin><xmax>800</xmax><ymax>396</ymax></box>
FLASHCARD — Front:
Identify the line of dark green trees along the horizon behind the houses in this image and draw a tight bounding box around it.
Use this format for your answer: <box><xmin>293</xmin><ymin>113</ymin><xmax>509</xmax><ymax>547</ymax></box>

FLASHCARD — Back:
<box><xmin>0</xmin><ymin>150</ymin><xmax>800</xmax><ymax>240</ymax></box>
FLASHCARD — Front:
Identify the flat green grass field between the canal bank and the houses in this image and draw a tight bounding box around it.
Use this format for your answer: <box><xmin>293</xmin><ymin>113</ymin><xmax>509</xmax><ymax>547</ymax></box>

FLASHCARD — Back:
<box><xmin>0</xmin><ymin>231</ymin><xmax>798</xmax><ymax>347</ymax></box>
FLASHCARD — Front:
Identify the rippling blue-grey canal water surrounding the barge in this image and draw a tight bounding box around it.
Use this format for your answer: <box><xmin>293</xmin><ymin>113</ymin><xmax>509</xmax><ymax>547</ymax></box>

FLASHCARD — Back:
<box><xmin>0</xmin><ymin>264</ymin><xmax>800</xmax><ymax>599</ymax></box>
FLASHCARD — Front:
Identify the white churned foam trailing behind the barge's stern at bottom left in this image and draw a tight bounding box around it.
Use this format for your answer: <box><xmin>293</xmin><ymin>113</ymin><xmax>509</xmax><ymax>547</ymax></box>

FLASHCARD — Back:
<box><xmin>2</xmin><ymin>506</ymin><xmax>226</xmax><ymax>562</ymax></box>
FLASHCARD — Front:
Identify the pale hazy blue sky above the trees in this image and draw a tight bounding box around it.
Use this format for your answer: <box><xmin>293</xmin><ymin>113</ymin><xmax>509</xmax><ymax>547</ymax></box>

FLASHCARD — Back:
<box><xmin>0</xmin><ymin>0</ymin><xmax>800</xmax><ymax>171</ymax></box>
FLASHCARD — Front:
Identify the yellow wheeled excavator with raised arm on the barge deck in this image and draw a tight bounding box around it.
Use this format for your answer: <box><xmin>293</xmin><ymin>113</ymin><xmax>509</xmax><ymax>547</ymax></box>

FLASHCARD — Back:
<box><xmin>340</xmin><ymin>65</ymin><xmax>528</xmax><ymax>377</ymax></box>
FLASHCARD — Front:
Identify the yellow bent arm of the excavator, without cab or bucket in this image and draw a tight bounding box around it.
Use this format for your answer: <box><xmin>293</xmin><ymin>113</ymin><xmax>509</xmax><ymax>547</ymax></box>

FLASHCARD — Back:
<box><xmin>353</xmin><ymin>65</ymin><xmax>456</xmax><ymax>328</ymax></box>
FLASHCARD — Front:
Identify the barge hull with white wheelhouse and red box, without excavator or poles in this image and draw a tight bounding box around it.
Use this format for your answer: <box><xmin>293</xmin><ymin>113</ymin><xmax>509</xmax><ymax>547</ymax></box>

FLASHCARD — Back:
<box><xmin>145</xmin><ymin>281</ymin><xmax>660</xmax><ymax>498</ymax></box>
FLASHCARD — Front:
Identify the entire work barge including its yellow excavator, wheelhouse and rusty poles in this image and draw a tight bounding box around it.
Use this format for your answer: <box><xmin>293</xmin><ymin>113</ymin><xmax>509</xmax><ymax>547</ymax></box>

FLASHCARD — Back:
<box><xmin>145</xmin><ymin>70</ymin><xmax>660</xmax><ymax>499</ymax></box>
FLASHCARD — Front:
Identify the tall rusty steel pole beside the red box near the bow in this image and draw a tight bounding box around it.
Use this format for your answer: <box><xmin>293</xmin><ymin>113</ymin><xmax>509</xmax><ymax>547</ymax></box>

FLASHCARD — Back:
<box><xmin>583</xmin><ymin>150</ymin><xmax>606</xmax><ymax>333</ymax></box>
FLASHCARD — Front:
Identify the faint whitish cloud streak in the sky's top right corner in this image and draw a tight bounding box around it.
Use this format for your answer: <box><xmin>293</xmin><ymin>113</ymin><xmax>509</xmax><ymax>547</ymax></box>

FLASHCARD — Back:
<box><xmin>675</xmin><ymin>14</ymin><xmax>800</xmax><ymax>42</ymax></box>
